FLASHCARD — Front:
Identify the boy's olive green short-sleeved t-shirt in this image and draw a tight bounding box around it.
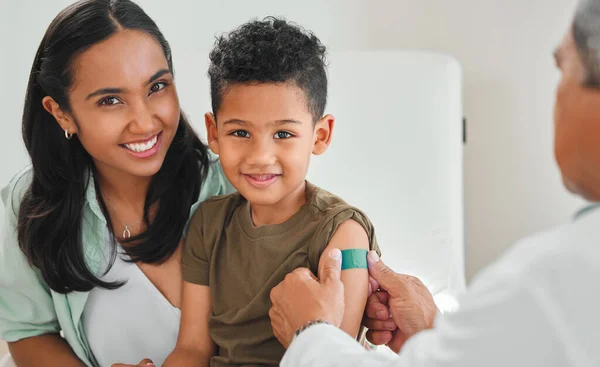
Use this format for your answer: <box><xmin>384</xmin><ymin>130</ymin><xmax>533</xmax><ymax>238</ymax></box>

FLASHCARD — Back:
<box><xmin>182</xmin><ymin>182</ymin><xmax>379</xmax><ymax>367</ymax></box>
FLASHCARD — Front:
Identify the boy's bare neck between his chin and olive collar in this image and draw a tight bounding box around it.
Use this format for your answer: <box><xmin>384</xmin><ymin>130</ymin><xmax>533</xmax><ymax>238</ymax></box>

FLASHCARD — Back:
<box><xmin>250</xmin><ymin>181</ymin><xmax>306</xmax><ymax>227</ymax></box>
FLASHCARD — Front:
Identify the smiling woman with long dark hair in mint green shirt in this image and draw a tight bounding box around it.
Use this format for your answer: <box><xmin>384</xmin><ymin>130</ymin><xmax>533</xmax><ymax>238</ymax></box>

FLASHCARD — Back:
<box><xmin>0</xmin><ymin>0</ymin><xmax>231</xmax><ymax>366</ymax></box>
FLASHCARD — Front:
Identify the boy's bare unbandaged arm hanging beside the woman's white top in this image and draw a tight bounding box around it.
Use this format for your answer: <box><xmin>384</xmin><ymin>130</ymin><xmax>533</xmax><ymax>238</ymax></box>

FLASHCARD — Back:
<box><xmin>163</xmin><ymin>282</ymin><xmax>216</xmax><ymax>367</ymax></box>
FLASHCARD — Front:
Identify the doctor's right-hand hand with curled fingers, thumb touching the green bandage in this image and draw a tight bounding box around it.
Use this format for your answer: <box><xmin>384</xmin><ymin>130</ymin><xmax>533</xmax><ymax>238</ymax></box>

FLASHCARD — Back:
<box><xmin>363</xmin><ymin>251</ymin><xmax>438</xmax><ymax>353</ymax></box>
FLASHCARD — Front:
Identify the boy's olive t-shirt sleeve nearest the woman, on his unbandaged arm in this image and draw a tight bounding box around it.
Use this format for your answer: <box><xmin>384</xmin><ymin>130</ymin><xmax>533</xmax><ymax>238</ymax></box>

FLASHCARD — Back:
<box><xmin>181</xmin><ymin>206</ymin><xmax>210</xmax><ymax>285</ymax></box>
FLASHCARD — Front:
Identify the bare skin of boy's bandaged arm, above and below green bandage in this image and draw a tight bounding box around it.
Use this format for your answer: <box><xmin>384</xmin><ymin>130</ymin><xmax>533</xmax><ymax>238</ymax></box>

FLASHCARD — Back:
<box><xmin>319</xmin><ymin>219</ymin><xmax>370</xmax><ymax>337</ymax></box>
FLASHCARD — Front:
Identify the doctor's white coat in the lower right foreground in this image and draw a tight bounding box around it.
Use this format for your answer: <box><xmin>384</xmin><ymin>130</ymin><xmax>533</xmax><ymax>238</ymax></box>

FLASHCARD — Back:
<box><xmin>281</xmin><ymin>208</ymin><xmax>600</xmax><ymax>367</ymax></box>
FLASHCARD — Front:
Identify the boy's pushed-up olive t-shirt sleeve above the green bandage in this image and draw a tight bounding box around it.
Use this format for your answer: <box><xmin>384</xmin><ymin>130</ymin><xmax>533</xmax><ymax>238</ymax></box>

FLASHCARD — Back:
<box><xmin>308</xmin><ymin>205</ymin><xmax>381</xmax><ymax>272</ymax></box>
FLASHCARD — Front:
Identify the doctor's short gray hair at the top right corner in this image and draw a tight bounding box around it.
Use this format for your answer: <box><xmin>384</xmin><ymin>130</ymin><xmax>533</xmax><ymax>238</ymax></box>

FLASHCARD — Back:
<box><xmin>573</xmin><ymin>0</ymin><xmax>600</xmax><ymax>88</ymax></box>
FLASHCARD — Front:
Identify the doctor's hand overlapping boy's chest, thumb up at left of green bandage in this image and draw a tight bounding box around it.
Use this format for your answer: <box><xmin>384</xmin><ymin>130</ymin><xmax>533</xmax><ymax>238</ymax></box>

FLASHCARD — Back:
<box><xmin>269</xmin><ymin>249</ymin><xmax>344</xmax><ymax>348</ymax></box>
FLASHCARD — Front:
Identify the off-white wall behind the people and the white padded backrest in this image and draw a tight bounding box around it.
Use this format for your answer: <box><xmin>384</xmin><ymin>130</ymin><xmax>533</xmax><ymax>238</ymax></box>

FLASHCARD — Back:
<box><xmin>0</xmin><ymin>0</ymin><xmax>581</xmax><ymax>278</ymax></box>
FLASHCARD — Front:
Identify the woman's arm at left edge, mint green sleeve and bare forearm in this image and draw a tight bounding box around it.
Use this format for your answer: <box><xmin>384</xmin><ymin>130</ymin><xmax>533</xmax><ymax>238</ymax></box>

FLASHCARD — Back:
<box><xmin>0</xmin><ymin>171</ymin><xmax>85</xmax><ymax>367</ymax></box>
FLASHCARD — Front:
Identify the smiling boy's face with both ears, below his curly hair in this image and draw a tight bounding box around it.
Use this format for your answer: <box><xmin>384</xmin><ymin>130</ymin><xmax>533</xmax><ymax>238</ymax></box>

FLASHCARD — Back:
<box><xmin>206</xmin><ymin>83</ymin><xmax>334</xmax><ymax>206</ymax></box>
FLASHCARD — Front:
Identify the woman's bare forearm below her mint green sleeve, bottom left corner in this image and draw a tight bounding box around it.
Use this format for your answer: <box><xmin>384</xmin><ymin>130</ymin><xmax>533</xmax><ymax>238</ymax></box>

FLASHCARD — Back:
<box><xmin>8</xmin><ymin>334</ymin><xmax>85</xmax><ymax>367</ymax></box>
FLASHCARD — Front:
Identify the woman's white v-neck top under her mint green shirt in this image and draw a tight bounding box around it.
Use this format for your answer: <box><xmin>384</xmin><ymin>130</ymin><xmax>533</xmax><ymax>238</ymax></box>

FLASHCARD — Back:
<box><xmin>83</xmin><ymin>246</ymin><xmax>181</xmax><ymax>367</ymax></box>
